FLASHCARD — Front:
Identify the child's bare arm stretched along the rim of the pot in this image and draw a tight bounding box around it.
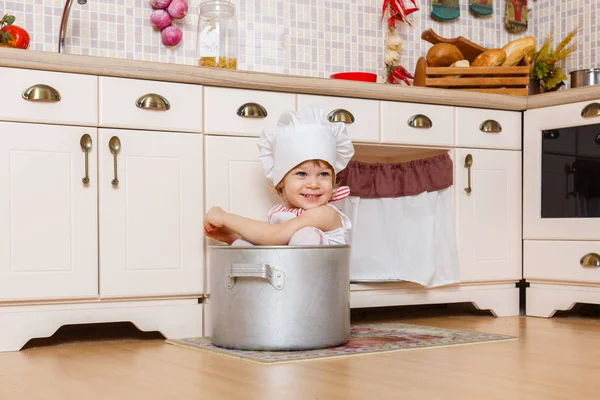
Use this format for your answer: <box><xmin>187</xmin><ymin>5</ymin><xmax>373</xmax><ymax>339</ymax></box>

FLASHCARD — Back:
<box><xmin>205</xmin><ymin>205</ymin><xmax>342</xmax><ymax>246</ymax></box>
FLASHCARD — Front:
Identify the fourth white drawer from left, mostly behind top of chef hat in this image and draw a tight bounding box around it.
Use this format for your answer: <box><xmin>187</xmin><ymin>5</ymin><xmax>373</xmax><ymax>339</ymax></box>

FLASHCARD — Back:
<box><xmin>298</xmin><ymin>95</ymin><xmax>379</xmax><ymax>143</ymax></box>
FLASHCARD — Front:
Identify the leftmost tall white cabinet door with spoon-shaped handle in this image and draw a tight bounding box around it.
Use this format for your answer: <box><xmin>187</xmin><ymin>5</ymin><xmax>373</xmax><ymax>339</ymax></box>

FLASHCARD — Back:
<box><xmin>0</xmin><ymin>122</ymin><xmax>98</xmax><ymax>301</ymax></box>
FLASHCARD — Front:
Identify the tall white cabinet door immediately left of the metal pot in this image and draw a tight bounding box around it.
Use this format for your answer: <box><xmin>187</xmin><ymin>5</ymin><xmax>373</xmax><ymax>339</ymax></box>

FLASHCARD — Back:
<box><xmin>98</xmin><ymin>129</ymin><xmax>204</xmax><ymax>297</ymax></box>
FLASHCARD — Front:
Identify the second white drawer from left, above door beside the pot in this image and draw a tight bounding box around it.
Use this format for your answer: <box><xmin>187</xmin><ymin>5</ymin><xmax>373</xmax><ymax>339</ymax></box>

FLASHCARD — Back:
<box><xmin>100</xmin><ymin>77</ymin><xmax>202</xmax><ymax>132</ymax></box>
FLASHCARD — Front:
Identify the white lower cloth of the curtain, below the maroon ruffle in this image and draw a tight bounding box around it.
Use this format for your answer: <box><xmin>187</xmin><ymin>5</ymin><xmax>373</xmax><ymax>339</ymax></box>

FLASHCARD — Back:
<box><xmin>337</xmin><ymin>188</ymin><xmax>459</xmax><ymax>287</ymax></box>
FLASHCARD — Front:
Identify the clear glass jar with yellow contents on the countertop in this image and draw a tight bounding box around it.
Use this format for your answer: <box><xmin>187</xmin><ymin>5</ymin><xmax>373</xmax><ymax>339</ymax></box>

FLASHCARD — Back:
<box><xmin>196</xmin><ymin>0</ymin><xmax>237</xmax><ymax>69</ymax></box>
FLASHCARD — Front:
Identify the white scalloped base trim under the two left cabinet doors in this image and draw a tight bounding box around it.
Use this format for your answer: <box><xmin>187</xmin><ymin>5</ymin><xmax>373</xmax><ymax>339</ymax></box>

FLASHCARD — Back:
<box><xmin>0</xmin><ymin>299</ymin><xmax>203</xmax><ymax>352</ymax></box>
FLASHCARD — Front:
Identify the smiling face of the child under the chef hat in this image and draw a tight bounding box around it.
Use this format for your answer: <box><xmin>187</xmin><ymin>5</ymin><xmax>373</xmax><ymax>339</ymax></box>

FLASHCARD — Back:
<box><xmin>282</xmin><ymin>160</ymin><xmax>333</xmax><ymax>210</ymax></box>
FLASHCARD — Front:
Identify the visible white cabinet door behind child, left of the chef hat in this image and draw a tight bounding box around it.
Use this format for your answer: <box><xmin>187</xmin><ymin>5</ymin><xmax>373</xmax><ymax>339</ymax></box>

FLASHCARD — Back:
<box><xmin>206</xmin><ymin>136</ymin><xmax>281</xmax><ymax>221</ymax></box>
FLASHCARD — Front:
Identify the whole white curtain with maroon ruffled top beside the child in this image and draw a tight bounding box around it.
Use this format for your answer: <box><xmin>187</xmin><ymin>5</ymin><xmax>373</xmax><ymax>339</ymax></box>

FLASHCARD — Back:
<box><xmin>338</xmin><ymin>154</ymin><xmax>460</xmax><ymax>287</ymax></box>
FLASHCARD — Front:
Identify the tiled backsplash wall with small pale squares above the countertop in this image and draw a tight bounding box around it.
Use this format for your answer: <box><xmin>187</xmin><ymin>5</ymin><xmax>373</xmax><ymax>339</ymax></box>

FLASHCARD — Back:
<box><xmin>0</xmin><ymin>0</ymin><xmax>600</xmax><ymax>81</ymax></box>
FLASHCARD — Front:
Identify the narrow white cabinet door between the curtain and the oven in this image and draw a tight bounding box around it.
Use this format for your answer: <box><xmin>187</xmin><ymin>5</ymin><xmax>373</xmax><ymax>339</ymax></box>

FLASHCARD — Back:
<box><xmin>454</xmin><ymin>148</ymin><xmax>522</xmax><ymax>282</ymax></box>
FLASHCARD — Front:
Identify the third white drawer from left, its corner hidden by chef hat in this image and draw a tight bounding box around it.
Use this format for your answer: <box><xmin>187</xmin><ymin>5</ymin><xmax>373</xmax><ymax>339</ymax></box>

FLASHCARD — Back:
<box><xmin>204</xmin><ymin>87</ymin><xmax>296</xmax><ymax>136</ymax></box>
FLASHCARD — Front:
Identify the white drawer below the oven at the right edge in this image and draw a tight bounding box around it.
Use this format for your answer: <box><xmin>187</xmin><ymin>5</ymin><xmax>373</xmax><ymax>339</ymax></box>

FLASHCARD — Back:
<box><xmin>523</xmin><ymin>240</ymin><xmax>600</xmax><ymax>283</ymax></box>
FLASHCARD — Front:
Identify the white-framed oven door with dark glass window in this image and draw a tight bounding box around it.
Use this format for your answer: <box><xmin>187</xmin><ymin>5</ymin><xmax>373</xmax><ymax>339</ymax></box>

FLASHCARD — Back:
<box><xmin>523</xmin><ymin>102</ymin><xmax>600</xmax><ymax>240</ymax></box>
